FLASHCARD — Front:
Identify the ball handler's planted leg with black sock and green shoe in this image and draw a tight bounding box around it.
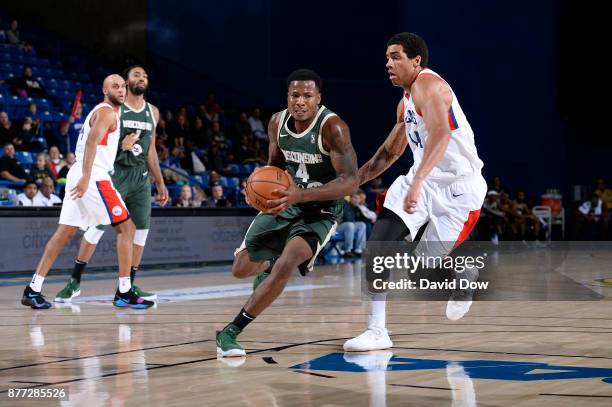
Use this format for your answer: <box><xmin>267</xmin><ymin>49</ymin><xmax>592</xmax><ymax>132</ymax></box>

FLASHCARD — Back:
<box><xmin>216</xmin><ymin>236</ymin><xmax>316</xmax><ymax>357</ymax></box>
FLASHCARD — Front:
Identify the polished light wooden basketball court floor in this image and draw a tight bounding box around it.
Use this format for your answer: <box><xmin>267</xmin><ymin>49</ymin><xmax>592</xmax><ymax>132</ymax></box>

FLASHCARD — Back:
<box><xmin>0</xmin><ymin>262</ymin><xmax>612</xmax><ymax>407</ymax></box>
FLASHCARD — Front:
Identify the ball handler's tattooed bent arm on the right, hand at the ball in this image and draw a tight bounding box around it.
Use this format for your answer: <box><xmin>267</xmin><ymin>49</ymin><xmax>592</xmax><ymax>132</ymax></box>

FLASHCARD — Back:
<box><xmin>268</xmin><ymin>116</ymin><xmax>359</xmax><ymax>214</ymax></box>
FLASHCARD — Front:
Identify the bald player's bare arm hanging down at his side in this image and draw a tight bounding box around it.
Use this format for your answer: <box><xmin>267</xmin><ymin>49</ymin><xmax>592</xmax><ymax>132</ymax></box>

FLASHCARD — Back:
<box><xmin>70</xmin><ymin>108</ymin><xmax>117</xmax><ymax>199</ymax></box>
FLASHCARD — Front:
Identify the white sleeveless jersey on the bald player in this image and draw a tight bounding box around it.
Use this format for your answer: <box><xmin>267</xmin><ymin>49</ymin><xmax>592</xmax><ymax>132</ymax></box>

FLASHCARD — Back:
<box><xmin>74</xmin><ymin>102</ymin><xmax>121</xmax><ymax>172</ymax></box>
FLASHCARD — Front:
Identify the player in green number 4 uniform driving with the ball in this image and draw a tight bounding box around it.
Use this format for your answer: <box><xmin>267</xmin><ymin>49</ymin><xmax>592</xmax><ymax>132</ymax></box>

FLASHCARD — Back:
<box><xmin>216</xmin><ymin>69</ymin><xmax>358</xmax><ymax>357</ymax></box>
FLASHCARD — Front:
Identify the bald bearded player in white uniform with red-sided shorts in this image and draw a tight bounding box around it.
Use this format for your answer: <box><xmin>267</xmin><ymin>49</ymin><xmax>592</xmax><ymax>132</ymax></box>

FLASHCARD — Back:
<box><xmin>21</xmin><ymin>75</ymin><xmax>154</xmax><ymax>309</ymax></box>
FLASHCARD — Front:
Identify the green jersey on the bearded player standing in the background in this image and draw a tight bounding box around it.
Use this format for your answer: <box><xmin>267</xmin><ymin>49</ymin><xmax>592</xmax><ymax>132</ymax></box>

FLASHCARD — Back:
<box><xmin>115</xmin><ymin>102</ymin><xmax>157</xmax><ymax>167</ymax></box>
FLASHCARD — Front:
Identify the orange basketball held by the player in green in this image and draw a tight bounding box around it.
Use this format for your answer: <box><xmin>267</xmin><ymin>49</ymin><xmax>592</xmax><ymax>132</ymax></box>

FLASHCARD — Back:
<box><xmin>244</xmin><ymin>165</ymin><xmax>289</xmax><ymax>211</ymax></box>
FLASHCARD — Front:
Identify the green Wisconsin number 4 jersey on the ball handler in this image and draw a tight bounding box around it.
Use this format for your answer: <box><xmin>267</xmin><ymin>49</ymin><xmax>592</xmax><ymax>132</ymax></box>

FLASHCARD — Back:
<box><xmin>278</xmin><ymin>106</ymin><xmax>336</xmax><ymax>207</ymax></box>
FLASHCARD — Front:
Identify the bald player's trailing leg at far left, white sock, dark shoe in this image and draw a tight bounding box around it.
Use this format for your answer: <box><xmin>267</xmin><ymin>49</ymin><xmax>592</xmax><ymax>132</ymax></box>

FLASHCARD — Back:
<box><xmin>21</xmin><ymin>224</ymin><xmax>79</xmax><ymax>309</ymax></box>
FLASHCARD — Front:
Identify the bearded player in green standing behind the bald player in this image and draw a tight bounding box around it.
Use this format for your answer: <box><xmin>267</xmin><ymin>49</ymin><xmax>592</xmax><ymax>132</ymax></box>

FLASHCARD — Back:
<box><xmin>55</xmin><ymin>65</ymin><xmax>168</xmax><ymax>302</ymax></box>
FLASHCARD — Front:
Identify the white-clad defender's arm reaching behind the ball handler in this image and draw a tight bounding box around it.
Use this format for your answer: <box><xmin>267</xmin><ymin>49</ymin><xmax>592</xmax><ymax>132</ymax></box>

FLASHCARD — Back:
<box><xmin>359</xmin><ymin>100</ymin><xmax>408</xmax><ymax>185</ymax></box>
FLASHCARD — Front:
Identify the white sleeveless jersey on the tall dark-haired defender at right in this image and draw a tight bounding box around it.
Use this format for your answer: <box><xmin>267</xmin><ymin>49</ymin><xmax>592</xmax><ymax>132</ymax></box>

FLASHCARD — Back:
<box><xmin>404</xmin><ymin>69</ymin><xmax>483</xmax><ymax>181</ymax></box>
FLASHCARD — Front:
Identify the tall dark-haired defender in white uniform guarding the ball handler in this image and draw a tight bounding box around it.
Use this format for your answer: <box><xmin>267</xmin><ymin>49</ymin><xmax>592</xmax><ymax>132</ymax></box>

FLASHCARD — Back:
<box><xmin>344</xmin><ymin>32</ymin><xmax>487</xmax><ymax>351</ymax></box>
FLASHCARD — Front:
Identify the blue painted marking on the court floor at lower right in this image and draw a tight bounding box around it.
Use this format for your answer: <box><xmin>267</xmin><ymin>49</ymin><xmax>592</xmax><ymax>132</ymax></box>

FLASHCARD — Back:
<box><xmin>290</xmin><ymin>353</ymin><xmax>612</xmax><ymax>384</ymax></box>
